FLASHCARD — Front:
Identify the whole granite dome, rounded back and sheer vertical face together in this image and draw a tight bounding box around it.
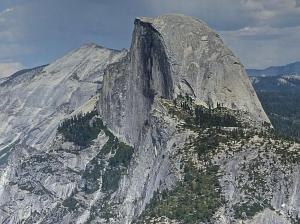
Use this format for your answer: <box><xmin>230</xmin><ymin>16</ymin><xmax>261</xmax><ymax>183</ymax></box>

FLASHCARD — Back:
<box><xmin>100</xmin><ymin>15</ymin><xmax>269</xmax><ymax>143</ymax></box>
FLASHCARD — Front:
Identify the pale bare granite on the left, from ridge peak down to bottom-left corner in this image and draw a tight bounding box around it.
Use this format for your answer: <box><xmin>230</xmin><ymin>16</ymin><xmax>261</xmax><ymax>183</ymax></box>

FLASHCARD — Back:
<box><xmin>0</xmin><ymin>44</ymin><xmax>126</xmax><ymax>223</ymax></box>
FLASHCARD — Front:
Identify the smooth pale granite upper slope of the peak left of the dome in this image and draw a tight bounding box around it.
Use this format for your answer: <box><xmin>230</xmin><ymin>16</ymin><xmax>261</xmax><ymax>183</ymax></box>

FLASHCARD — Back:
<box><xmin>0</xmin><ymin>44</ymin><xmax>124</xmax><ymax>152</ymax></box>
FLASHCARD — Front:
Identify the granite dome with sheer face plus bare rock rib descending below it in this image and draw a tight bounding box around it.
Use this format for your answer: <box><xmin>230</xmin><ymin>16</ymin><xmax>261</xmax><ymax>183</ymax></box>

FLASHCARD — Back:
<box><xmin>98</xmin><ymin>15</ymin><xmax>276</xmax><ymax>222</ymax></box>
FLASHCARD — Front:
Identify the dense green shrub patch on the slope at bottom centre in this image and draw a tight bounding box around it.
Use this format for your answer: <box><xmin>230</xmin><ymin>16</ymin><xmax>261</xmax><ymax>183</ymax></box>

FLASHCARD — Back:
<box><xmin>138</xmin><ymin>162</ymin><xmax>224</xmax><ymax>224</ymax></box>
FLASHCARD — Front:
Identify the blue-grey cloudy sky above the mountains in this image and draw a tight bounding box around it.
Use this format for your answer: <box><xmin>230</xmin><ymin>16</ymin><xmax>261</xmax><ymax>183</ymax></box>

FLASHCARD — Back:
<box><xmin>0</xmin><ymin>0</ymin><xmax>300</xmax><ymax>77</ymax></box>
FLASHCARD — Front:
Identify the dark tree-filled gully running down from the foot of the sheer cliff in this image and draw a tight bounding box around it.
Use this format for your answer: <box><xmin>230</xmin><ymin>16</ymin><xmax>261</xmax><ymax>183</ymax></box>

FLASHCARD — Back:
<box><xmin>82</xmin><ymin>135</ymin><xmax>134</xmax><ymax>222</ymax></box>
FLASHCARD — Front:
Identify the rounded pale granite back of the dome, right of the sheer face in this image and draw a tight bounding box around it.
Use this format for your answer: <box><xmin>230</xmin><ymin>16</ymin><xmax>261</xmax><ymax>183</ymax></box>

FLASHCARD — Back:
<box><xmin>135</xmin><ymin>14</ymin><xmax>269</xmax><ymax>122</ymax></box>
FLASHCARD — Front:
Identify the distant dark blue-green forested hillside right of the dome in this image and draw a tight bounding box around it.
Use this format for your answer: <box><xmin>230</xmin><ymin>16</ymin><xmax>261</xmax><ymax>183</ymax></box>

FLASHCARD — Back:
<box><xmin>251</xmin><ymin>75</ymin><xmax>300</xmax><ymax>139</ymax></box>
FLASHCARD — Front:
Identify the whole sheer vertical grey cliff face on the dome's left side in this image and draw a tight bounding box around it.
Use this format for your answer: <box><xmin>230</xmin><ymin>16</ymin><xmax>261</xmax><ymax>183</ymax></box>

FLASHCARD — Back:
<box><xmin>99</xmin><ymin>17</ymin><xmax>174</xmax><ymax>143</ymax></box>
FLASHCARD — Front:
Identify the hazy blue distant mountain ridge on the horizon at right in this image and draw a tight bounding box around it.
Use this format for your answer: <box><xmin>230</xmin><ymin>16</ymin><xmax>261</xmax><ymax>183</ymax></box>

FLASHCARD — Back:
<box><xmin>247</xmin><ymin>61</ymin><xmax>300</xmax><ymax>76</ymax></box>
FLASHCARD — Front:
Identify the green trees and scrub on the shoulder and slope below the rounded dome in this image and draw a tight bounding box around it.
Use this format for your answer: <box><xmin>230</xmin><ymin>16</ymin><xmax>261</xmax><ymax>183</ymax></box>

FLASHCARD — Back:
<box><xmin>152</xmin><ymin>93</ymin><xmax>299</xmax><ymax>223</ymax></box>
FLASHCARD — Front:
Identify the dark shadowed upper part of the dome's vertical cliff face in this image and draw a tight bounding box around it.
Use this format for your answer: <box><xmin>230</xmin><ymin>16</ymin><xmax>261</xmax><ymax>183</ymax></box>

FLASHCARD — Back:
<box><xmin>131</xmin><ymin>19</ymin><xmax>174</xmax><ymax>101</ymax></box>
